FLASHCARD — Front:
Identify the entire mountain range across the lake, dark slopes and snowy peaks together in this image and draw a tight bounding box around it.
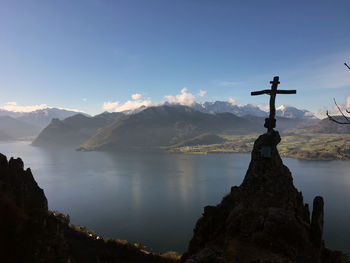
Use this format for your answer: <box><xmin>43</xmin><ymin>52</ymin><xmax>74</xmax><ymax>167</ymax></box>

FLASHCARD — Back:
<box><xmin>0</xmin><ymin>101</ymin><xmax>328</xmax><ymax>150</ymax></box>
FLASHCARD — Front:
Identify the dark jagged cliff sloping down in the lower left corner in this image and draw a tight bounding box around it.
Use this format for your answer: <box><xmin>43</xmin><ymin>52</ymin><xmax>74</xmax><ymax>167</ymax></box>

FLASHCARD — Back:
<box><xmin>0</xmin><ymin>154</ymin><xmax>175</xmax><ymax>263</ymax></box>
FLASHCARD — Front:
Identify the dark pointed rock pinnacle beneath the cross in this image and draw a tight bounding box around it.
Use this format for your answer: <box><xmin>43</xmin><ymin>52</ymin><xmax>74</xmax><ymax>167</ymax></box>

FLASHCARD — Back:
<box><xmin>182</xmin><ymin>131</ymin><xmax>342</xmax><ymax>263</ymax></box>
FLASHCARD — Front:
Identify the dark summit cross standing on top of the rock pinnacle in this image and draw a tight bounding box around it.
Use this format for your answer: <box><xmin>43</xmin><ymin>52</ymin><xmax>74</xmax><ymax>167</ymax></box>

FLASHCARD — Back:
<box><xmin>251</xmin><ymin>76</ymin><xmax>297</xmax><ymax>132</ymax></box>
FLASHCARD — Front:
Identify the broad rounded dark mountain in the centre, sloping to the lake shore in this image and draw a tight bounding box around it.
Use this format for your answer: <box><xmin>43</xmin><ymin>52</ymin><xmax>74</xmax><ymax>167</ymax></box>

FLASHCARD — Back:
<box><xmin>80</xmin><ymin>105</ymin><xmax>261</xmax><ymax>150</ymax></box>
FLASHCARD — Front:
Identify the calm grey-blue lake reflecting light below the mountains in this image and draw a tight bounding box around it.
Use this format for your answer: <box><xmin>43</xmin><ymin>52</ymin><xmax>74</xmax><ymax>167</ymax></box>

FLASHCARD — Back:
<box><xmin>0</xmin><ymin>142</ymin><xmax>350</xmax><ymax>253</ymax></box>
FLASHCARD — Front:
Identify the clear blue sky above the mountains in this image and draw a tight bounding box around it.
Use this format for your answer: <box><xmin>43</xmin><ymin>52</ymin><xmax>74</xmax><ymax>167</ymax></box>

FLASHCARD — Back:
<box><xmin>0</xmin><ymin>0</ymin><xmax>350</xmax><ymax>114</ymax></box>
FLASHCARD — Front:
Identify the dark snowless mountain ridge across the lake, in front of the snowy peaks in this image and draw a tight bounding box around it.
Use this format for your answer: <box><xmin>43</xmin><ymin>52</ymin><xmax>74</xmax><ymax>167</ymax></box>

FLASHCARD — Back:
<box><xmin>33</xmin><ymin>103</ymin><xmax>314</xmax><ymax>151</ymax></box>
